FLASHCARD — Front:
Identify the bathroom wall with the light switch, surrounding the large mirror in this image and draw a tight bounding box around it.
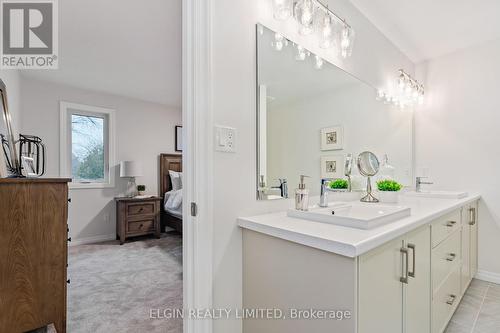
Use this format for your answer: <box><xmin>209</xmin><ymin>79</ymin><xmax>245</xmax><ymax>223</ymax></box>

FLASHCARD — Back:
<box><xmin>207</xmin><ymin>0</ymin><xmax>413</xmax><ymax>333</ymax></box>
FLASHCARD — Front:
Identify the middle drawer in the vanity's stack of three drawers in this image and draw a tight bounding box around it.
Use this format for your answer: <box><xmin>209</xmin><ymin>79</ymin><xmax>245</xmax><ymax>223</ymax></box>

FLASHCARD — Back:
<box><xmin>432</xmin><ymin>230</ymin><xmax>461</xmax><ymax>292</ymax></box>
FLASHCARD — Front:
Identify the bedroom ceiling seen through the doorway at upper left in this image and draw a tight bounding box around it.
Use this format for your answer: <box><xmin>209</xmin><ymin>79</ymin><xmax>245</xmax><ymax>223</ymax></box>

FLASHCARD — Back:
<box><xmin>23</xmin><ymin>0</ymin><xmax>182</xmax><ymax>107</ymax></box>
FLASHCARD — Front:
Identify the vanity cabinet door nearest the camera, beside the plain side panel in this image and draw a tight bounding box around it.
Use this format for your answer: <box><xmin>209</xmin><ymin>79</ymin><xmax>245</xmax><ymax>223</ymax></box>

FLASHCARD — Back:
<box><xmin>358</xmin><ymin>238</ymin><xmax>406</xmax><ymax>333</ymax></box>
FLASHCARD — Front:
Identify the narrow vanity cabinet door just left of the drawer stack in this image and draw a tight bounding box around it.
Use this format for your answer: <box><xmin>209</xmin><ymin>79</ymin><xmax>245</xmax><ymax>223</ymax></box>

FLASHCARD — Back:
<box><xmin>406</xmin><ymin>225</ymin><xmax>431</xmax><ymax>333</ymax></box>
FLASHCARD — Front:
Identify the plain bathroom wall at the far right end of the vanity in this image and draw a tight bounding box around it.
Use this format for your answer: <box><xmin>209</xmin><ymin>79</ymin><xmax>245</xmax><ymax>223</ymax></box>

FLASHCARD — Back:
<box><xmin>416</xmin><ymin>40</ymin><xmax>500</xmax><ymax>281</ymax></box>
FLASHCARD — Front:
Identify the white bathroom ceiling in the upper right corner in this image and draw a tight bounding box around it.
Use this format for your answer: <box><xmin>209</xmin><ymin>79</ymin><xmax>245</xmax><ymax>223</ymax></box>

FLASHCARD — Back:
<box><xmin>351</xmin><ymin>0</ymin><xmax>500</xmax><ymax>63</ymax></box>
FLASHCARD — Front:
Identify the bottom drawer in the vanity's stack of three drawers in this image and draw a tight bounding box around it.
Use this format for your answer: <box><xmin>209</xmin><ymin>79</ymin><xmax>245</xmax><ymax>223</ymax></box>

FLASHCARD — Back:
<box><xmin>432</xmin><ymin>266</ymin><xmax>460</xmax><ymax>333</ymax></box>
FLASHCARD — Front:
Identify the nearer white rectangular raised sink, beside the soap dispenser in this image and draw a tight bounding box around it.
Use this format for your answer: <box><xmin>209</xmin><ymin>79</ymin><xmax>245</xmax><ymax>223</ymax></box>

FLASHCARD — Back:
<box><xmin>287</xmin><ymin>202</ymin><xmax>411</xmax><ymax>229</ymax></box>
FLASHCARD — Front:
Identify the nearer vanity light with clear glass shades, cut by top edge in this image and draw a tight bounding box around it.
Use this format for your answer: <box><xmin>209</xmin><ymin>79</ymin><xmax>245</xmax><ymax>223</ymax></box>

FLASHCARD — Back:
<box><xmin>272</xmin><ymin>0</ymin><xmax>355</xmax><ymax>58</ymax></box>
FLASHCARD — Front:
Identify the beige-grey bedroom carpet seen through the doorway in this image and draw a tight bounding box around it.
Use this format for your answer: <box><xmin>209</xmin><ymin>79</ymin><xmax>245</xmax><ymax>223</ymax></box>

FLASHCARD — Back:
<box><xmin>68</xmin><ymin>233</ymin><xmax>182</xmax><ymax>333</ymax></box>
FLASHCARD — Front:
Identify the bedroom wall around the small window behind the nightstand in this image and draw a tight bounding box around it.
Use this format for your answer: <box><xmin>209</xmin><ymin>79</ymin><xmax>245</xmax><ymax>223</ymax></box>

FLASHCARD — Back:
<box><xmin>21</xmin><ymin>78</ymin><xmax>182</xmax><ymax>241</ymax></box>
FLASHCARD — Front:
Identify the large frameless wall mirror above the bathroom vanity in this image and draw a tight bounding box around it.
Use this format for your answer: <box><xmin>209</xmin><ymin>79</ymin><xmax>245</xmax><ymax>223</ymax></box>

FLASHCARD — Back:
<box><xmin>257</xmin><ymin>26</ymin><xmax>413</xmax><ymax>200</ymax></box>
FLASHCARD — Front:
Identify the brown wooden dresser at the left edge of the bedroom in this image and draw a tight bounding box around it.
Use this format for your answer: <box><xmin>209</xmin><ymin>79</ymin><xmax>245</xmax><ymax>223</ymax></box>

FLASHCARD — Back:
<box><xmin>0</xmin><ymin>179</ymin><xmax>70</xmax><ymax>333</ymax></box>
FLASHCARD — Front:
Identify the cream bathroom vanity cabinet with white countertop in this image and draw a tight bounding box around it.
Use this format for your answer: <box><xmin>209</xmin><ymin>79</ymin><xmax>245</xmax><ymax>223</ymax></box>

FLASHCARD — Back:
<box><xmin>238</xmin><ymin>194</ymin><xmax>479</xmax><ymax>333</ymax></box>
